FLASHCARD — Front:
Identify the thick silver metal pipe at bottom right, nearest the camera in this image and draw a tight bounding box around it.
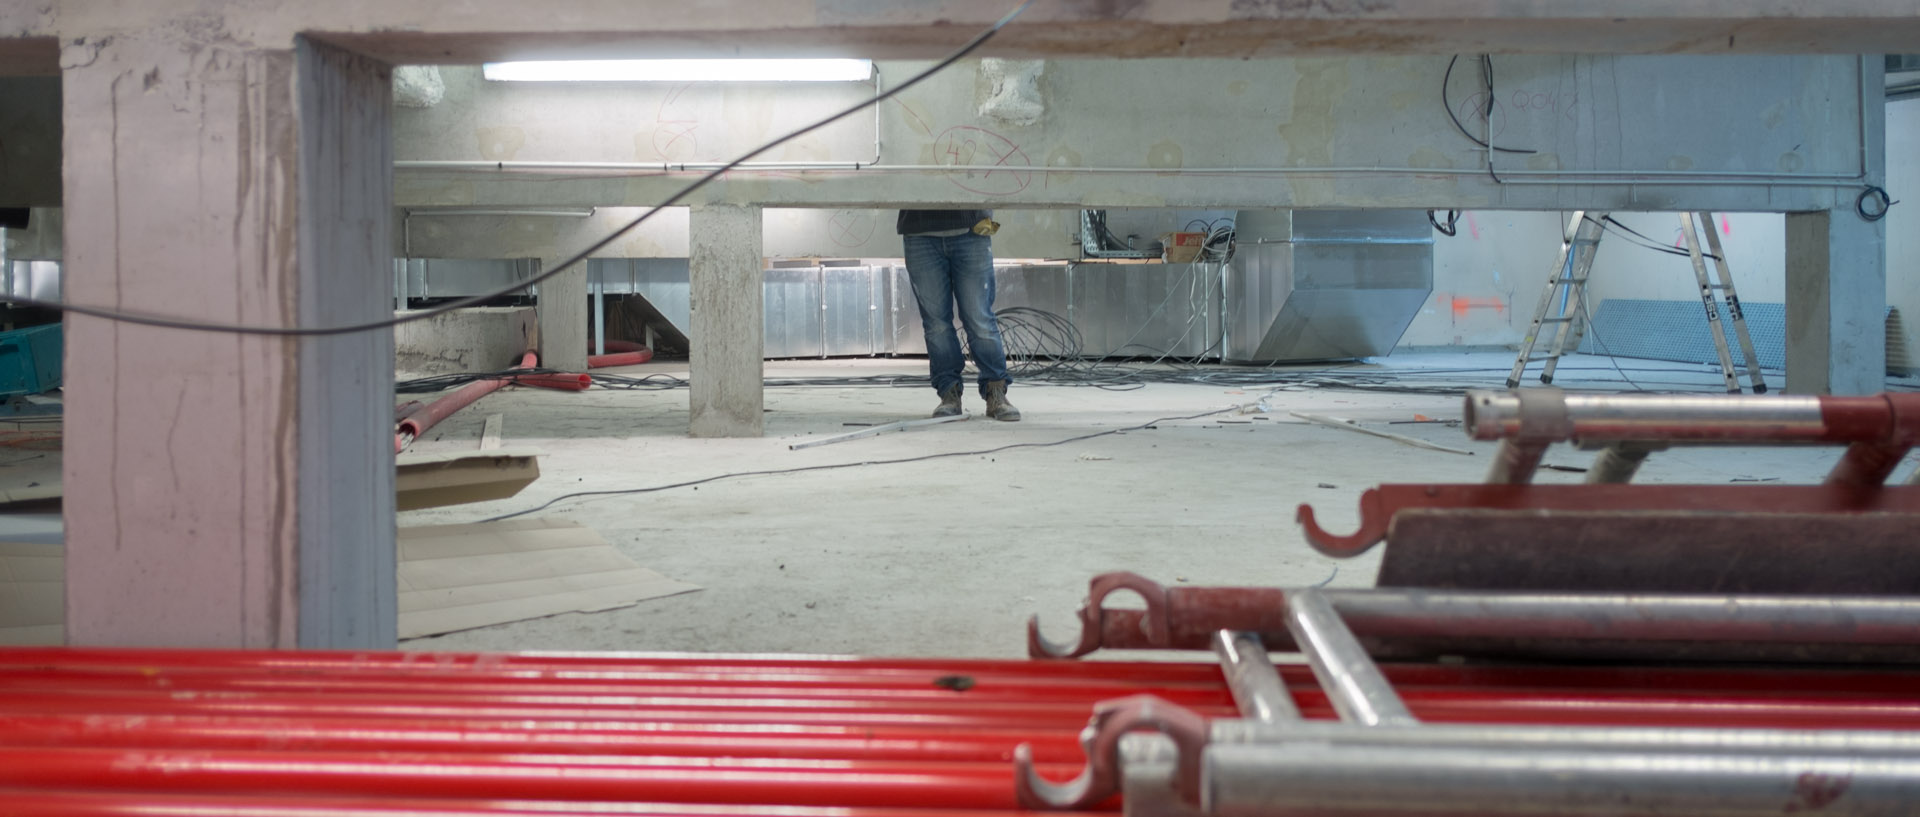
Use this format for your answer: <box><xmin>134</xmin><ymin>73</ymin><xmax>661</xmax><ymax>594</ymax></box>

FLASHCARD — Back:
<box><xmin>1202</xmin><ymin>744</ymin><xmax>1920</xmax><ymax>817</ymax></box>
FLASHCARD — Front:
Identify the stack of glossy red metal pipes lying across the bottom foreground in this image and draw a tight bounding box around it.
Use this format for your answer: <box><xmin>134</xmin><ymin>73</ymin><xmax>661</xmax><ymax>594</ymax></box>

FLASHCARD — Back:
<box><xmin>11</xmin><ymin>648</ymin><xmax>1920</xmax><ymax>817</ymax></box>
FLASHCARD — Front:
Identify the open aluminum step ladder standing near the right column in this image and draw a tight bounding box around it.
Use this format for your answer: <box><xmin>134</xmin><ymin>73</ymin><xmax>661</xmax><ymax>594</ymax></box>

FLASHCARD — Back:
<box><xmin>1507</xmin><ymin>211</ymin><xmax>1766</xmax><ymax>395</ymax></box>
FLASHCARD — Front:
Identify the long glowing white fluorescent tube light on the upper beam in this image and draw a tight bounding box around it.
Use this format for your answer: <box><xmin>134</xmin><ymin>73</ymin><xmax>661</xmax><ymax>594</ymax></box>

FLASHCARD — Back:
<box><xmin>480</xmin><ymin>59</ymin><xmax>874</xmax><ymax>82</ymax></box>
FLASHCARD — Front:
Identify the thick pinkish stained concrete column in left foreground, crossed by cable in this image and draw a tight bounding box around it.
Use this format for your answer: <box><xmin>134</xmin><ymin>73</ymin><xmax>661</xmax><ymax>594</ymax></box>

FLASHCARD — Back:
<box><xmin>61</xmin><ymin>27</ymin><xmax>396</xmax><ymax>648</ymax></box>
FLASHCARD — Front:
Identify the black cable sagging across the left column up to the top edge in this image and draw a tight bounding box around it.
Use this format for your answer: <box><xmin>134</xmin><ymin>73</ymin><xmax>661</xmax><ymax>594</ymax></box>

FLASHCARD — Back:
<box><xmin>6</xmin><ymin>0</ymin><xmax>1035</xmax><ymax>338</ymax></box>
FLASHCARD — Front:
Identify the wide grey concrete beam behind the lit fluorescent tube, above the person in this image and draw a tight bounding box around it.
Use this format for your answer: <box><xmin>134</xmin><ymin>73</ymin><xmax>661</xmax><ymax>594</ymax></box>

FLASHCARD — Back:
<box><xmin>396</xmin><ymin>56</ymin><xmax>1884</xmax><ymax>213</ymax></box>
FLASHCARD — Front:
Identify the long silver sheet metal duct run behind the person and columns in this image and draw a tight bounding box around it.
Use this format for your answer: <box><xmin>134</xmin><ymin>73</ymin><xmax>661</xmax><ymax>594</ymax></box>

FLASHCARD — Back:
<box><xmin>487</xmin><ymin>211</ymin><xmax>1432</xmax><ymax>362</ymax></box>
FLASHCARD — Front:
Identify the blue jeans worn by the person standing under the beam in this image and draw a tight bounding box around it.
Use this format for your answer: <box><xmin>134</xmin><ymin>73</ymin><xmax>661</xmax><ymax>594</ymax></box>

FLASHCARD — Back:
<box><xmin>900</xmin><ymin>234</ymin><xmax>1008</xmax><ymax>391</ymax></box>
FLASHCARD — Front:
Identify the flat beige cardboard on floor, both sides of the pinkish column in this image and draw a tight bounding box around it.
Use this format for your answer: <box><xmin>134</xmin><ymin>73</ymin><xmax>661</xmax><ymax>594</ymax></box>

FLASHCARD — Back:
<box><xmin>0</xmin><ymin>520</ymin><xmax>699</xmax><ymax>646</ymax></box>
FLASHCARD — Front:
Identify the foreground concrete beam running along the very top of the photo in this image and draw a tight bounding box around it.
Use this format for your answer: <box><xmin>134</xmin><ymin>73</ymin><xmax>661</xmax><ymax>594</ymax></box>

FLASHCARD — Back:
<box><xmin>0</xmin><ymin>0</ymin><xmax>1920</xmax><ymax>63</ymax></box>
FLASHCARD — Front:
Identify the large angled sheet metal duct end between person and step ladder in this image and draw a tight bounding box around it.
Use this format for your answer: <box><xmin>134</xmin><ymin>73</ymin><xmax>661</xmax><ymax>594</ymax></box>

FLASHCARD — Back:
<box><xmin>1225</xmin><ymin>211</ymin><xmax>1434</xmax><ymax>362</ymax></box>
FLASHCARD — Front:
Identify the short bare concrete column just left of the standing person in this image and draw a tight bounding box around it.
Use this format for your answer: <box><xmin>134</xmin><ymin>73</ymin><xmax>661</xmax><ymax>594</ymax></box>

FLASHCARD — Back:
<box><xmin>687</xmin><ymin>205</ymin><xmax>766</xmax><ymax>437</ymax></box>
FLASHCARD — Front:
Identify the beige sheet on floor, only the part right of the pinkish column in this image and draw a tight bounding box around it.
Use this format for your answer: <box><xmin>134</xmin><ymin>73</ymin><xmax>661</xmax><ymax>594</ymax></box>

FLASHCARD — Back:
<box><xmin>399</xmin><ymin>520</ymin><xmax>699</xmax><ymax>639</ymax></box>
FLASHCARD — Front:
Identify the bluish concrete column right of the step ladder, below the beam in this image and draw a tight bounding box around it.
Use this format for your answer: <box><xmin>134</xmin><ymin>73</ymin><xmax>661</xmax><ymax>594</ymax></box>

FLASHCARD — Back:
<box><xmin>1786</xmin><ymin>207</ymin><xmax>1887</xmax><ymax>395</ymax></box>
